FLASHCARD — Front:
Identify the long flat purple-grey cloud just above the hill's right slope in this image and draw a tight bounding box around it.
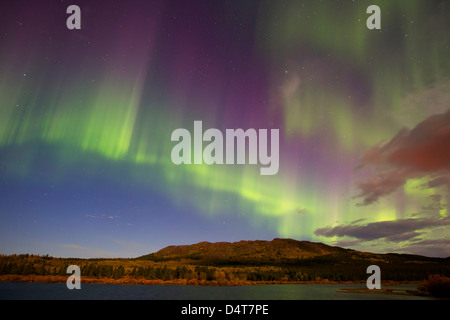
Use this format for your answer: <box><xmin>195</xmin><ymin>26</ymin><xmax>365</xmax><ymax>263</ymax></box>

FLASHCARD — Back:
<box><xmin>314</xmin><ymin>218</ymin><xmax>450</xmax><ymax>242</ymax></box>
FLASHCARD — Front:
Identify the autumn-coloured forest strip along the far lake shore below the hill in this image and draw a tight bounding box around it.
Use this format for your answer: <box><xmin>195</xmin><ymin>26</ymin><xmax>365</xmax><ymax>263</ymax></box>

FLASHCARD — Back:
<box><xmin>0</xmin><ymin>255</ymin><xmax>450</xmax><ymax>282</ymax></box>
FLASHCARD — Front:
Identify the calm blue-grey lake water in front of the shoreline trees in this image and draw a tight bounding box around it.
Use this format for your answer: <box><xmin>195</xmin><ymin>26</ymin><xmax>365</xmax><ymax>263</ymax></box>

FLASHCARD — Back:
<box><xmin>0</xmin><ymin>282</ymin><xmax>432</xmax><ymax>300</ymax></box>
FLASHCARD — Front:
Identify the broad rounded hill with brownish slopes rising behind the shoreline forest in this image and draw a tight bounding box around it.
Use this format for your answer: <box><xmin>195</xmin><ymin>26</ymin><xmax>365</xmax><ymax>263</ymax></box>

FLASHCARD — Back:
<box><xmin>137</xmin><ymin>238</ymin><xmax>448</xmax><ymax>265</ymax></box>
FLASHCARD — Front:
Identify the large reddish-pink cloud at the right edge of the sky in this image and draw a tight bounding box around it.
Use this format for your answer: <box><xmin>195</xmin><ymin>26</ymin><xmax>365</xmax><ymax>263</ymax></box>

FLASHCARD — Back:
<box><xmin>357</xmin><ymin>109</ymin><xmax>450</xmax><ymax>205</ymax></box>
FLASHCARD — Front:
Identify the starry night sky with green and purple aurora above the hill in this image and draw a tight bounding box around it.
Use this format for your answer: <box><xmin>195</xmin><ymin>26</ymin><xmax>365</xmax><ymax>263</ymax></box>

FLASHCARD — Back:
<box><xmin>0</xmin><ymin>0</ymin><xmax>450</xmax><ymax>258</ymax></box>
